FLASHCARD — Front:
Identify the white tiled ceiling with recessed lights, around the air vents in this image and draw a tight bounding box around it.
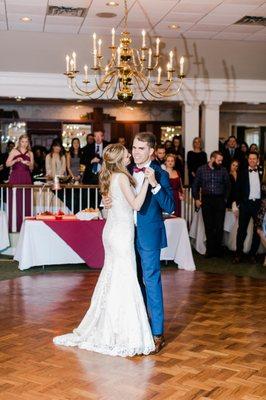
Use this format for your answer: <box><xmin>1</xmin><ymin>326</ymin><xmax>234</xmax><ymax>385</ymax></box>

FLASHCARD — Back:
<box><xmin>0</xmin><ymin>0</ymin><xmax>266</xmax><ymax>41</ymax></box>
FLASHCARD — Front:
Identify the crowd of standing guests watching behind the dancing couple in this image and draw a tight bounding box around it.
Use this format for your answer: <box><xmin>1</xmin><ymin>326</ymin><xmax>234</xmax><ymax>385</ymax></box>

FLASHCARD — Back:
<box><xmin>0</xmin><ymin>131</ymin><xmax>265</xmax><ymax>263</ymax></box>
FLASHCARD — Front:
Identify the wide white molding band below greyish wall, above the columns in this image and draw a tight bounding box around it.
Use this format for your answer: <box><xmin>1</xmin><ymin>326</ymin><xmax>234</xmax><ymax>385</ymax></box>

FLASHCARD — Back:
<box><xmin>0</xmin><ymin>71</ymin><xmax>266</xmax><ymax>105</ymax></box>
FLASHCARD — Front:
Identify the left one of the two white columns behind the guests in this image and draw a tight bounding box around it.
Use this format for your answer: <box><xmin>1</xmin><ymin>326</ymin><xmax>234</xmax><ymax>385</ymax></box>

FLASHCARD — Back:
<box><xmin>182</xmin><ymin>102</ymin><xmax>199</xmax><ymax>184</ymax></box>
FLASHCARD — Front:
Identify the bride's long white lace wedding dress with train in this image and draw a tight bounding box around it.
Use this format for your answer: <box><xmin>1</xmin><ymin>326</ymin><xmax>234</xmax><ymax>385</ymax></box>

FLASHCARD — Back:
<box><xmin>53</xmin><ymin>174</ymin><xmax>154</xmax><ymax>357</ymax></box>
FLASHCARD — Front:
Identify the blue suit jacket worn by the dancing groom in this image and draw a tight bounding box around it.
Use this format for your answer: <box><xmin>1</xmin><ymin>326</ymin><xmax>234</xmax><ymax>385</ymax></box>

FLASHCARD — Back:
<box><xmin>129</xmin><ymin>161</ymin><xmax>175</xmax><ymax>250</ymax></box>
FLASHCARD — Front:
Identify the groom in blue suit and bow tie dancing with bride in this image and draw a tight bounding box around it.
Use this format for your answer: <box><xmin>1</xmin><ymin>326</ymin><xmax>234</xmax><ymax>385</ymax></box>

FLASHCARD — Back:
<box><xmin>104</xmin><ymin>132</ymin><xmax>175</xmax><ymax>353</ymax></box>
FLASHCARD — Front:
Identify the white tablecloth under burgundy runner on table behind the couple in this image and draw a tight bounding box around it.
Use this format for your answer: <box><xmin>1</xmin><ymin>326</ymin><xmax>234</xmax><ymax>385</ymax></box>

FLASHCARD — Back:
<box><xmin>14</xmin><ymin>218</ymin><xmax>195</xmax><ymax>271</ymax></box>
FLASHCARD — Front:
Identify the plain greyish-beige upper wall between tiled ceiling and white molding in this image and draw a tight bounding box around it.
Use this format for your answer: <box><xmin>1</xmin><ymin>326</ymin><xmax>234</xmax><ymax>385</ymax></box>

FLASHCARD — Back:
<box><xmin>0</xmin><ymin>31</ymin><xmax>266</xmax><ymax>79</ymax></box>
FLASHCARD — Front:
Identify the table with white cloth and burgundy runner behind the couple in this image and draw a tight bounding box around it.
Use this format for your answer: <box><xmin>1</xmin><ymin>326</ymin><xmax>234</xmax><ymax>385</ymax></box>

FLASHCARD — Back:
<box><xmin>14</xmin><ymin>218</ymin><xmax>195</xmax><ymax>271</ymax></box>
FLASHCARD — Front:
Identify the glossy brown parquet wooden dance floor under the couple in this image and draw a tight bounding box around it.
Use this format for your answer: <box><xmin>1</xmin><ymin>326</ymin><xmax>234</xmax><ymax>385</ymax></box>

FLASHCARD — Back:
<box><xmin>0</xmin><ymin>269</ymin><xmax>266</xmax><ymax>400</ymax></box>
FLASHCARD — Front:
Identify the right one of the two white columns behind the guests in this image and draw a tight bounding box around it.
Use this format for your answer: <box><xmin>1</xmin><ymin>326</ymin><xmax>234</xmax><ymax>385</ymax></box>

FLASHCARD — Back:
<box><xmin>201</xmin><ymin>102</ymin><xmax>221</xmax><ymax>158</ymax></box>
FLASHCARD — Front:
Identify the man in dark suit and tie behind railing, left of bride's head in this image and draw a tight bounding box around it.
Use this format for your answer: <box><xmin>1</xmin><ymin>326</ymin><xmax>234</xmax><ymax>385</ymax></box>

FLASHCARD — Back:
<box><xmin>81</xmin><ymin>131</ymin><xmax>108</xmax><ymax>185</ymax></box>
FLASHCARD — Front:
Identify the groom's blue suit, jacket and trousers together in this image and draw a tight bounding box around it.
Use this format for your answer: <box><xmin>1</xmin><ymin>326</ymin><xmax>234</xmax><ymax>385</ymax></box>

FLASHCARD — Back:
<box><xmin>129</xmin><ymin>161</ymin><xmax>175</xmax><ymax>335</ymax></box>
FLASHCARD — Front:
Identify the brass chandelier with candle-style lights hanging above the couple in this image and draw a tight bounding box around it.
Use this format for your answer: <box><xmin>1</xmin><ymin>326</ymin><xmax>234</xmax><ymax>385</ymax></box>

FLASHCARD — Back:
<box><xmin>64</xmin><ymin>0</ymin><xmax>185</xmax><ymax>103</ymax></box>
